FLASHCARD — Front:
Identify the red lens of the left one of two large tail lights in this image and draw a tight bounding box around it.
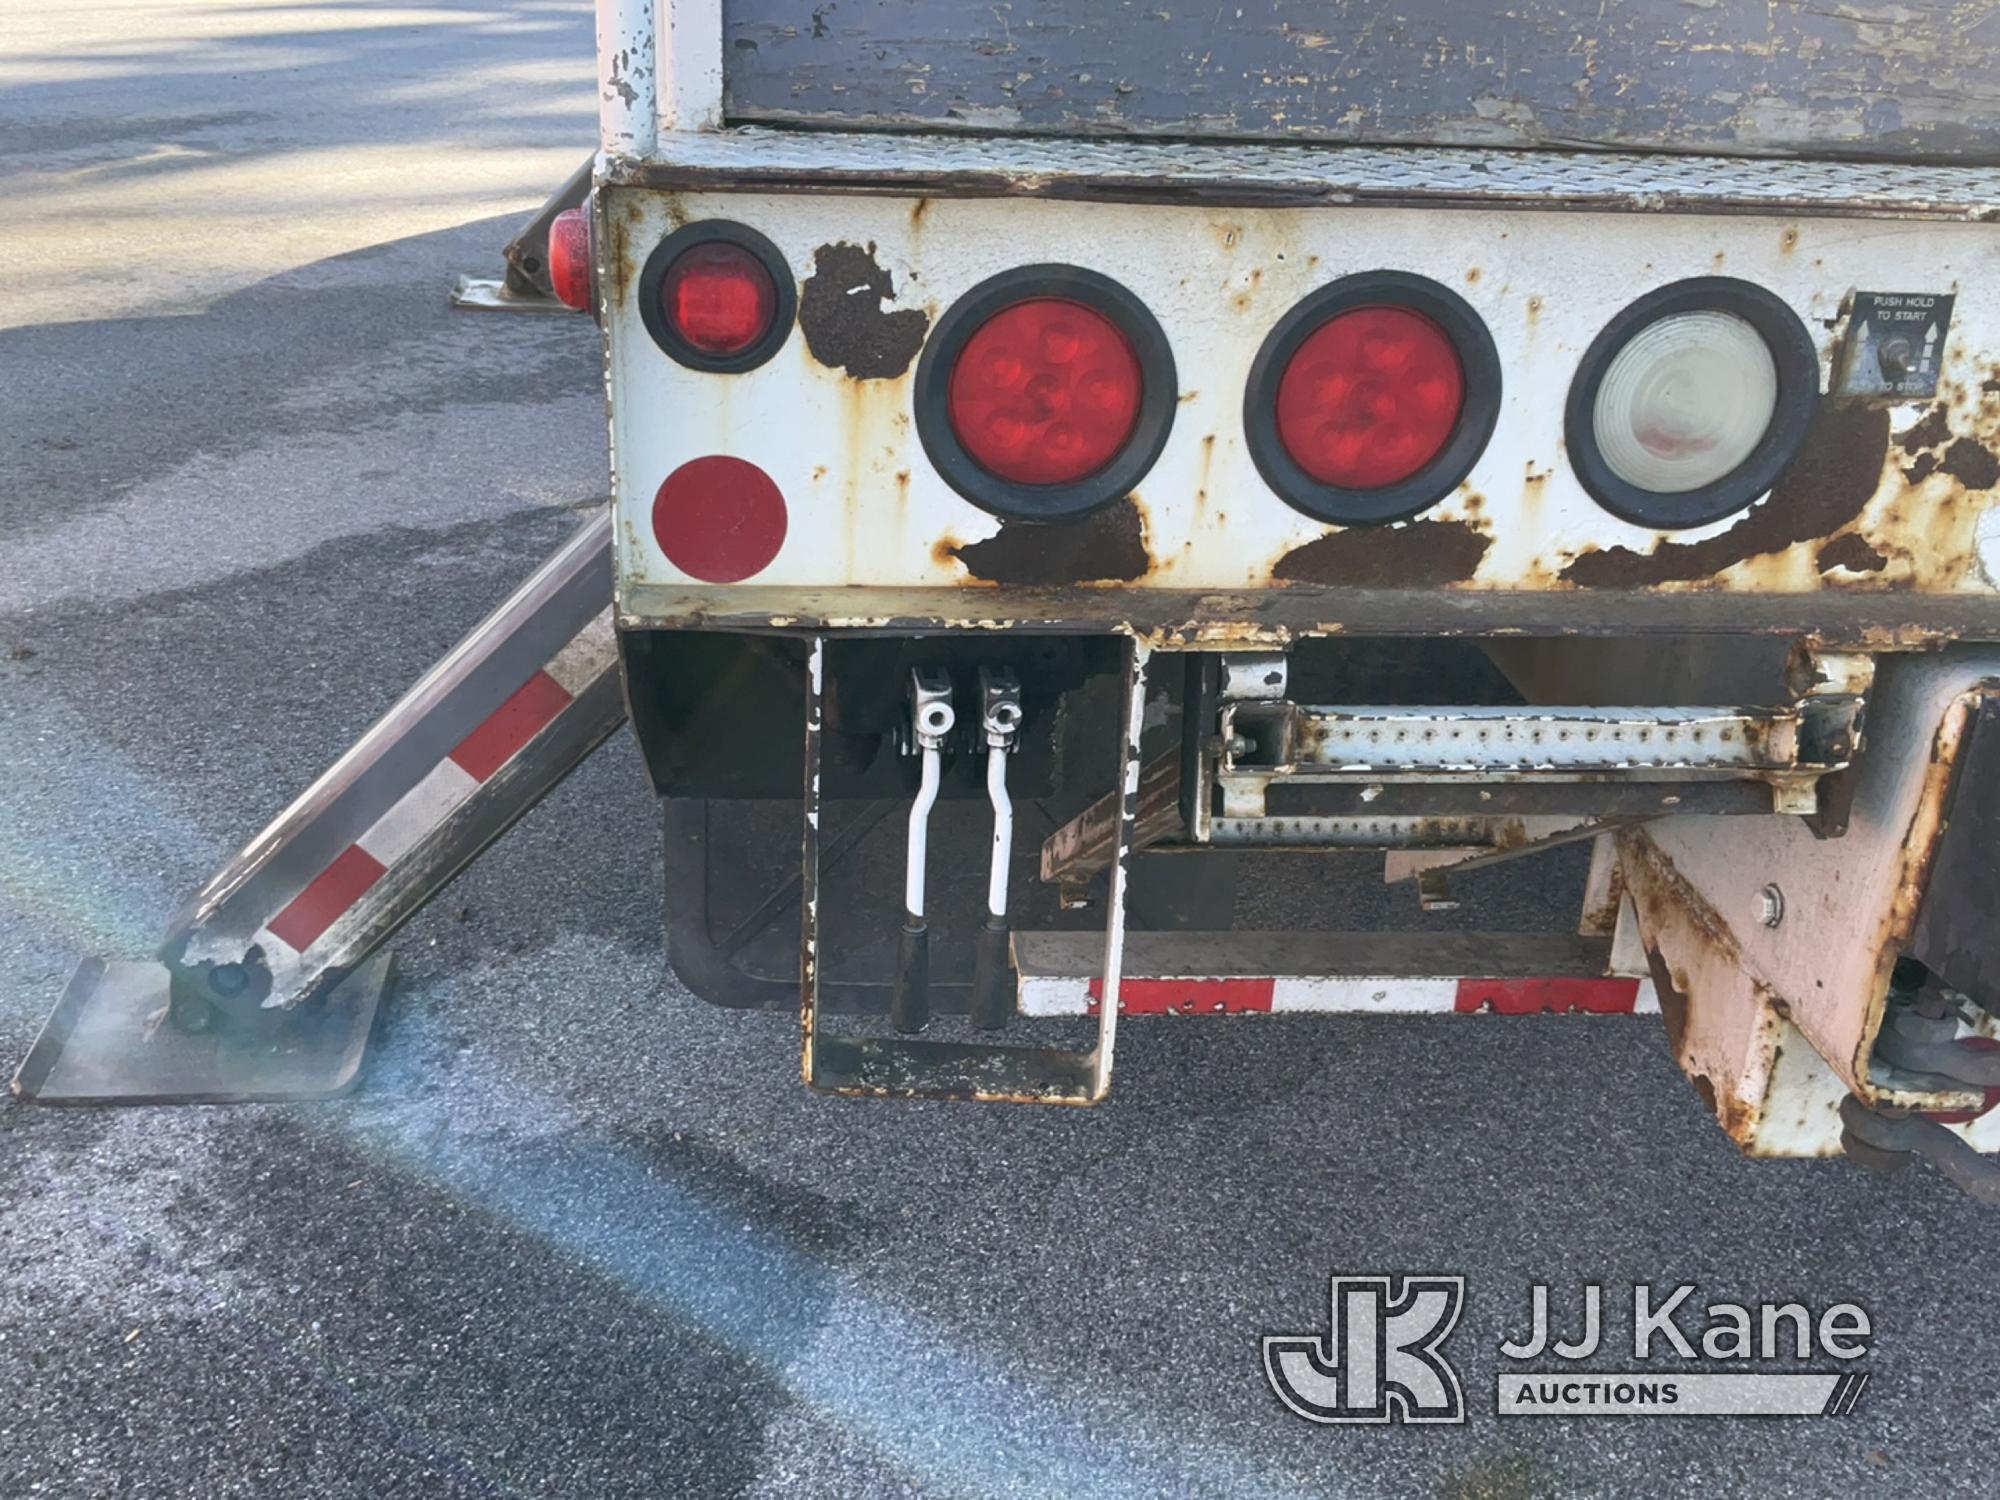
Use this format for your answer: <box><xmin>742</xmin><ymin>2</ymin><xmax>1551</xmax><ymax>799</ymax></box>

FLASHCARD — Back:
<box><xmin>946</xmin><ymin>298</ymin><xmax>1146</xmax><ymax>484</ymax></box>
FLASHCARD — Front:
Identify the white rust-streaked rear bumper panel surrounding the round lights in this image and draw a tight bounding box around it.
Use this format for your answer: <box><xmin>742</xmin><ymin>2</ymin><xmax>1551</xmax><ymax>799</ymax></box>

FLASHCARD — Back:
<box><xmin>600</xmin><ymin>188</ymin><xmax>2000</xmax><ymax>646</ymax></box>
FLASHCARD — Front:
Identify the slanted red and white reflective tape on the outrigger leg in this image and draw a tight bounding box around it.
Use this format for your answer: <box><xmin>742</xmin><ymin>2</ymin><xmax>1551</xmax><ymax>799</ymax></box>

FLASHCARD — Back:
<box><xmin>256</xmin><ymin>610</ymin><xmax>618</xmax><ymax>968</ymax></box>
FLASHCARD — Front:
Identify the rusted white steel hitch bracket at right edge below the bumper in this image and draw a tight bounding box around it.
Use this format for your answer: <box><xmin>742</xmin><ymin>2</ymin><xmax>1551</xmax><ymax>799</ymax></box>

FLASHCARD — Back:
<box><xmin>1618</xmin><ymin>648</ymin><xmax>2000</xmax><ymax>1156</ymax></box>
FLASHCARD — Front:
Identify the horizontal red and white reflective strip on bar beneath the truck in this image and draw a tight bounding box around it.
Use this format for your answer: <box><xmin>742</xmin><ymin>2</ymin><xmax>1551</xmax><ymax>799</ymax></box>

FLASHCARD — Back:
<box><xmin>1020</xmin><ymin>974</ymin><xmax>1660</xmax><ymax>1016</ymax></box>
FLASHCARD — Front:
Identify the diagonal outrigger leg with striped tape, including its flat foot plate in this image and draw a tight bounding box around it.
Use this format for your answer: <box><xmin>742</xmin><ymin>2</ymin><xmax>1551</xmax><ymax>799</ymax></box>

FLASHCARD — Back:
<box><xmin>14</xmin><ymin>508</ymin><xmax>624</xmax><ymax>1104</ymax></box>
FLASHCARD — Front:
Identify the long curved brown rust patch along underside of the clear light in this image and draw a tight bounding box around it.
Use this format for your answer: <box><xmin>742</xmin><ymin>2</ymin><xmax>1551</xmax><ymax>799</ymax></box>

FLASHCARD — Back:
<box><xmin>1562</xmin><ymin>400</ymin><xmax>1888</xmax><ymax>588</ymax></box>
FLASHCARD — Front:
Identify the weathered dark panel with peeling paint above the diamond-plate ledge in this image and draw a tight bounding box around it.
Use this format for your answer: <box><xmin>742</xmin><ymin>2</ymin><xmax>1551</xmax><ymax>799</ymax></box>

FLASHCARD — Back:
<box><xmin>722</xmin><ymin>0</ymin><xmax>2000</xmax><ymax>160</ymax></box>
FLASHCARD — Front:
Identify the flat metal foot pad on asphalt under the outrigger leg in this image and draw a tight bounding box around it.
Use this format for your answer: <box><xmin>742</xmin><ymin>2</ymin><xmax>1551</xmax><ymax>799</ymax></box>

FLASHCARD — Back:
<box><xmin>14</xmin><ymin>950</ymin><xmax>392</xmax><ymax>1104</ymax></box>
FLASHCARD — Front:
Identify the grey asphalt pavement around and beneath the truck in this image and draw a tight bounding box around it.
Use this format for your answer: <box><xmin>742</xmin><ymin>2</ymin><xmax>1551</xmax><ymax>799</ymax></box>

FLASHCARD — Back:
<box><xmin>0</xmin><ymin>0</ymin><xmax>2000</xmax><ymax>1500</ymax></box>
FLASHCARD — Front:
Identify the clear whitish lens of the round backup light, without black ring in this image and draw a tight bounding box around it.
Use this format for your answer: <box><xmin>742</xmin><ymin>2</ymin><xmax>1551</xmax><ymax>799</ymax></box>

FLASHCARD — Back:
<box><xmin>1590</xmin><ymin>312</ymin><xmax>1778</xmax><ymax>494</ymax></box>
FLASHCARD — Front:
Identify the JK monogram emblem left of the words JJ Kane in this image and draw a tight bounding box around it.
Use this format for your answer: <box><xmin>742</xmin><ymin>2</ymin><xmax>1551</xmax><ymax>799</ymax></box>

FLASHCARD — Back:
<box><xmin>1264</xmin><ymin>1276</ymin><xmax>1466</xmax><ymax>1422</ymax></box>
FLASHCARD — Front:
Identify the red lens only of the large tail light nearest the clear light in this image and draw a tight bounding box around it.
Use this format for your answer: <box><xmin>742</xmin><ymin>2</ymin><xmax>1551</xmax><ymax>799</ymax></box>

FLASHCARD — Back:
<box><xmin>1278</xmin><ymin>308</ymin><xmax>1466</xmax><ymax>490</ymax></box>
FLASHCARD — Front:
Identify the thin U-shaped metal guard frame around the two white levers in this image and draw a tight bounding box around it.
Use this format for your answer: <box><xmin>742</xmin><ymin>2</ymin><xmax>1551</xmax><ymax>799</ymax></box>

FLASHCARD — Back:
<box><xmin>798</xmin><ymin>636</ymin><xmax>1150</xmax><ymax>1104</ymax></box>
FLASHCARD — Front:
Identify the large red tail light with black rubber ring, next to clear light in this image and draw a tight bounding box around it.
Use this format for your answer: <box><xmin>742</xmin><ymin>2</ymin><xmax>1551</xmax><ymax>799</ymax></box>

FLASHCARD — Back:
<box><xmin>1244</xmin><ymin>270</ymin><xmax>1500</xmax><ymax>526</ymax></box>
